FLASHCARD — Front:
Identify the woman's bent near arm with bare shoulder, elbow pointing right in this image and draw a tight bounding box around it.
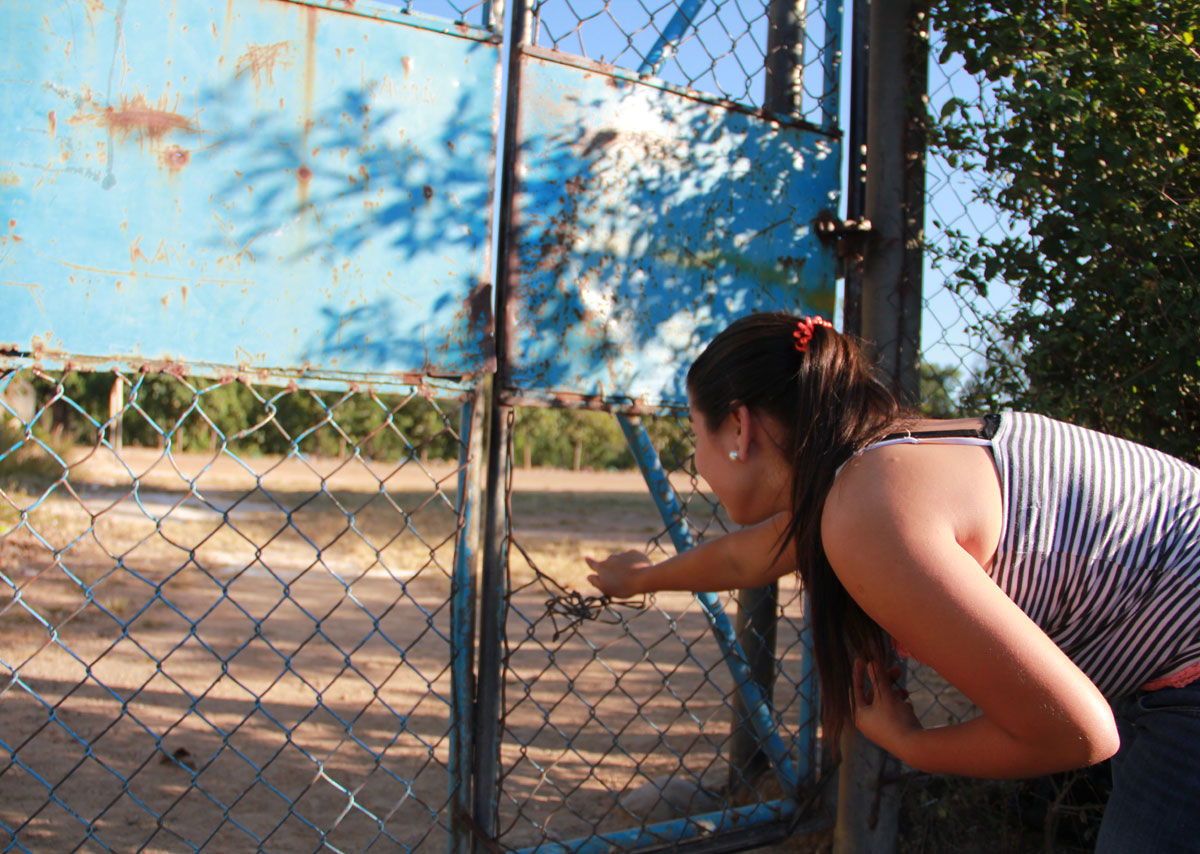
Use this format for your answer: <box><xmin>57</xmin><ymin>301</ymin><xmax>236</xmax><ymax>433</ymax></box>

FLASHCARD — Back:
<box><xmin>822</xmin><ymin>450</ymin><xmax>1118</xmax><ymax>777</ymax></box>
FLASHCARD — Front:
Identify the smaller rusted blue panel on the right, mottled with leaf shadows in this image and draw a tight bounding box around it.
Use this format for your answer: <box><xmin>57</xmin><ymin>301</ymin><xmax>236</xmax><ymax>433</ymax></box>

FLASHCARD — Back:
<box><xmin>509</xmin><ymin>55</ymin><xmax>839</xmax><ymax>404</ymax></box>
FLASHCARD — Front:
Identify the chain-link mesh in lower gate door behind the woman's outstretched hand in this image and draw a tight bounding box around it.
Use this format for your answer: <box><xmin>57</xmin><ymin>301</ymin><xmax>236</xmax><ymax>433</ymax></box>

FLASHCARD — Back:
<box><xmin>498</xmin><ymin>410</ymin><xmax>815</xmax><ymax>849</ymax></box>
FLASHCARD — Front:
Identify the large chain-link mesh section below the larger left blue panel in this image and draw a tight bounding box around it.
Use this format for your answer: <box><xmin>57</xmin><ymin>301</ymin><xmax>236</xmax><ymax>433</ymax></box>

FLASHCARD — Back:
<box><xmin>0</xmin><ymin>367</ymin><xmax>463</xmax><ymax>852</ymax></box>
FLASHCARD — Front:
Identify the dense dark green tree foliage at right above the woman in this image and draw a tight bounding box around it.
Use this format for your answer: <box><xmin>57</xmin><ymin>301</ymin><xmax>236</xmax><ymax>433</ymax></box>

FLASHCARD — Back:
<box><xmin>930</xmin><ymin>0</ymin><xmax>1200</xmax><ymax>462</ymax></box>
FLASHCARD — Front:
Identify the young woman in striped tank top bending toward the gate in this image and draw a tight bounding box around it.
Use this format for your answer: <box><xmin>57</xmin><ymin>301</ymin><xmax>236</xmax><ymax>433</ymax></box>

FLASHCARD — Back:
<box><xmin>588</xmin><ymin>313</ymin><xmax>1200</xmax><ymax>852</ymax></box>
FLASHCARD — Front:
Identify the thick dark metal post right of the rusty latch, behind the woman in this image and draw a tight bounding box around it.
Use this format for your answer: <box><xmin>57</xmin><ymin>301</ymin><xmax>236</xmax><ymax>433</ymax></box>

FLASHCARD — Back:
<box><xmin>834</xmin><ymin>0</ymin><xmax>928</xmax><ymax>854</ymax></box>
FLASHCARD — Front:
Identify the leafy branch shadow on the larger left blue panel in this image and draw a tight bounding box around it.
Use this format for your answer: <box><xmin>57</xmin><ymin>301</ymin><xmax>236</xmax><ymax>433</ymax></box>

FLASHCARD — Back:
<box><xmin>194</xmin><ymin>42</ymin><xmax>494</xmax><ymax>374</ymax></box>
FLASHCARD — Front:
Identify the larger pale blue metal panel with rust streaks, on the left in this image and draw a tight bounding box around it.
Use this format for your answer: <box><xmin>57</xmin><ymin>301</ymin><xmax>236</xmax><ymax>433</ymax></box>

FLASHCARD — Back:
<box><xmin>0</xmin><ymin>0</ymin><xmax>499</xmax><ymax>374</ymax></box>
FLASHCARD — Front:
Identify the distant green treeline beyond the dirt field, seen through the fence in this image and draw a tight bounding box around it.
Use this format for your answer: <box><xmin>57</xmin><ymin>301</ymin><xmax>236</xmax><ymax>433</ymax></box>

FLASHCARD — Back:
<box><xmin>7</xmin><ymin>372</ymin><xmax>690</xmax><ymax>470</ymax></box>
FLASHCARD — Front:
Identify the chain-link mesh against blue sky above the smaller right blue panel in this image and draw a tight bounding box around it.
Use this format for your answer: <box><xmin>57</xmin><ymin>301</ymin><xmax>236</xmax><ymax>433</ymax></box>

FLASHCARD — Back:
<box><xmin>530</xmin><ymin>0</ymin><xmax>841</xmax><ymax>126</ymax></box>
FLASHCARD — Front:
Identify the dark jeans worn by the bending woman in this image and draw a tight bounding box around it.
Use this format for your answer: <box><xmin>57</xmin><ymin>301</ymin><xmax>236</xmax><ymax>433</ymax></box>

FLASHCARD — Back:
<box><xmin>1096</xmin><ymin>680</ymin><xmax>1200</xmax><ymax>854</ymax></box>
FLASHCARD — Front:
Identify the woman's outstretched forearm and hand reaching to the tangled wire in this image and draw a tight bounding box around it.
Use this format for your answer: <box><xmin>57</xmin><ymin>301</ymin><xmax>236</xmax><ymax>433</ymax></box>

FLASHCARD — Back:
<box><xmin>586</xmin><ymin>513</ymin><xmax>796</xmax><ymax>599</ymax></box>
